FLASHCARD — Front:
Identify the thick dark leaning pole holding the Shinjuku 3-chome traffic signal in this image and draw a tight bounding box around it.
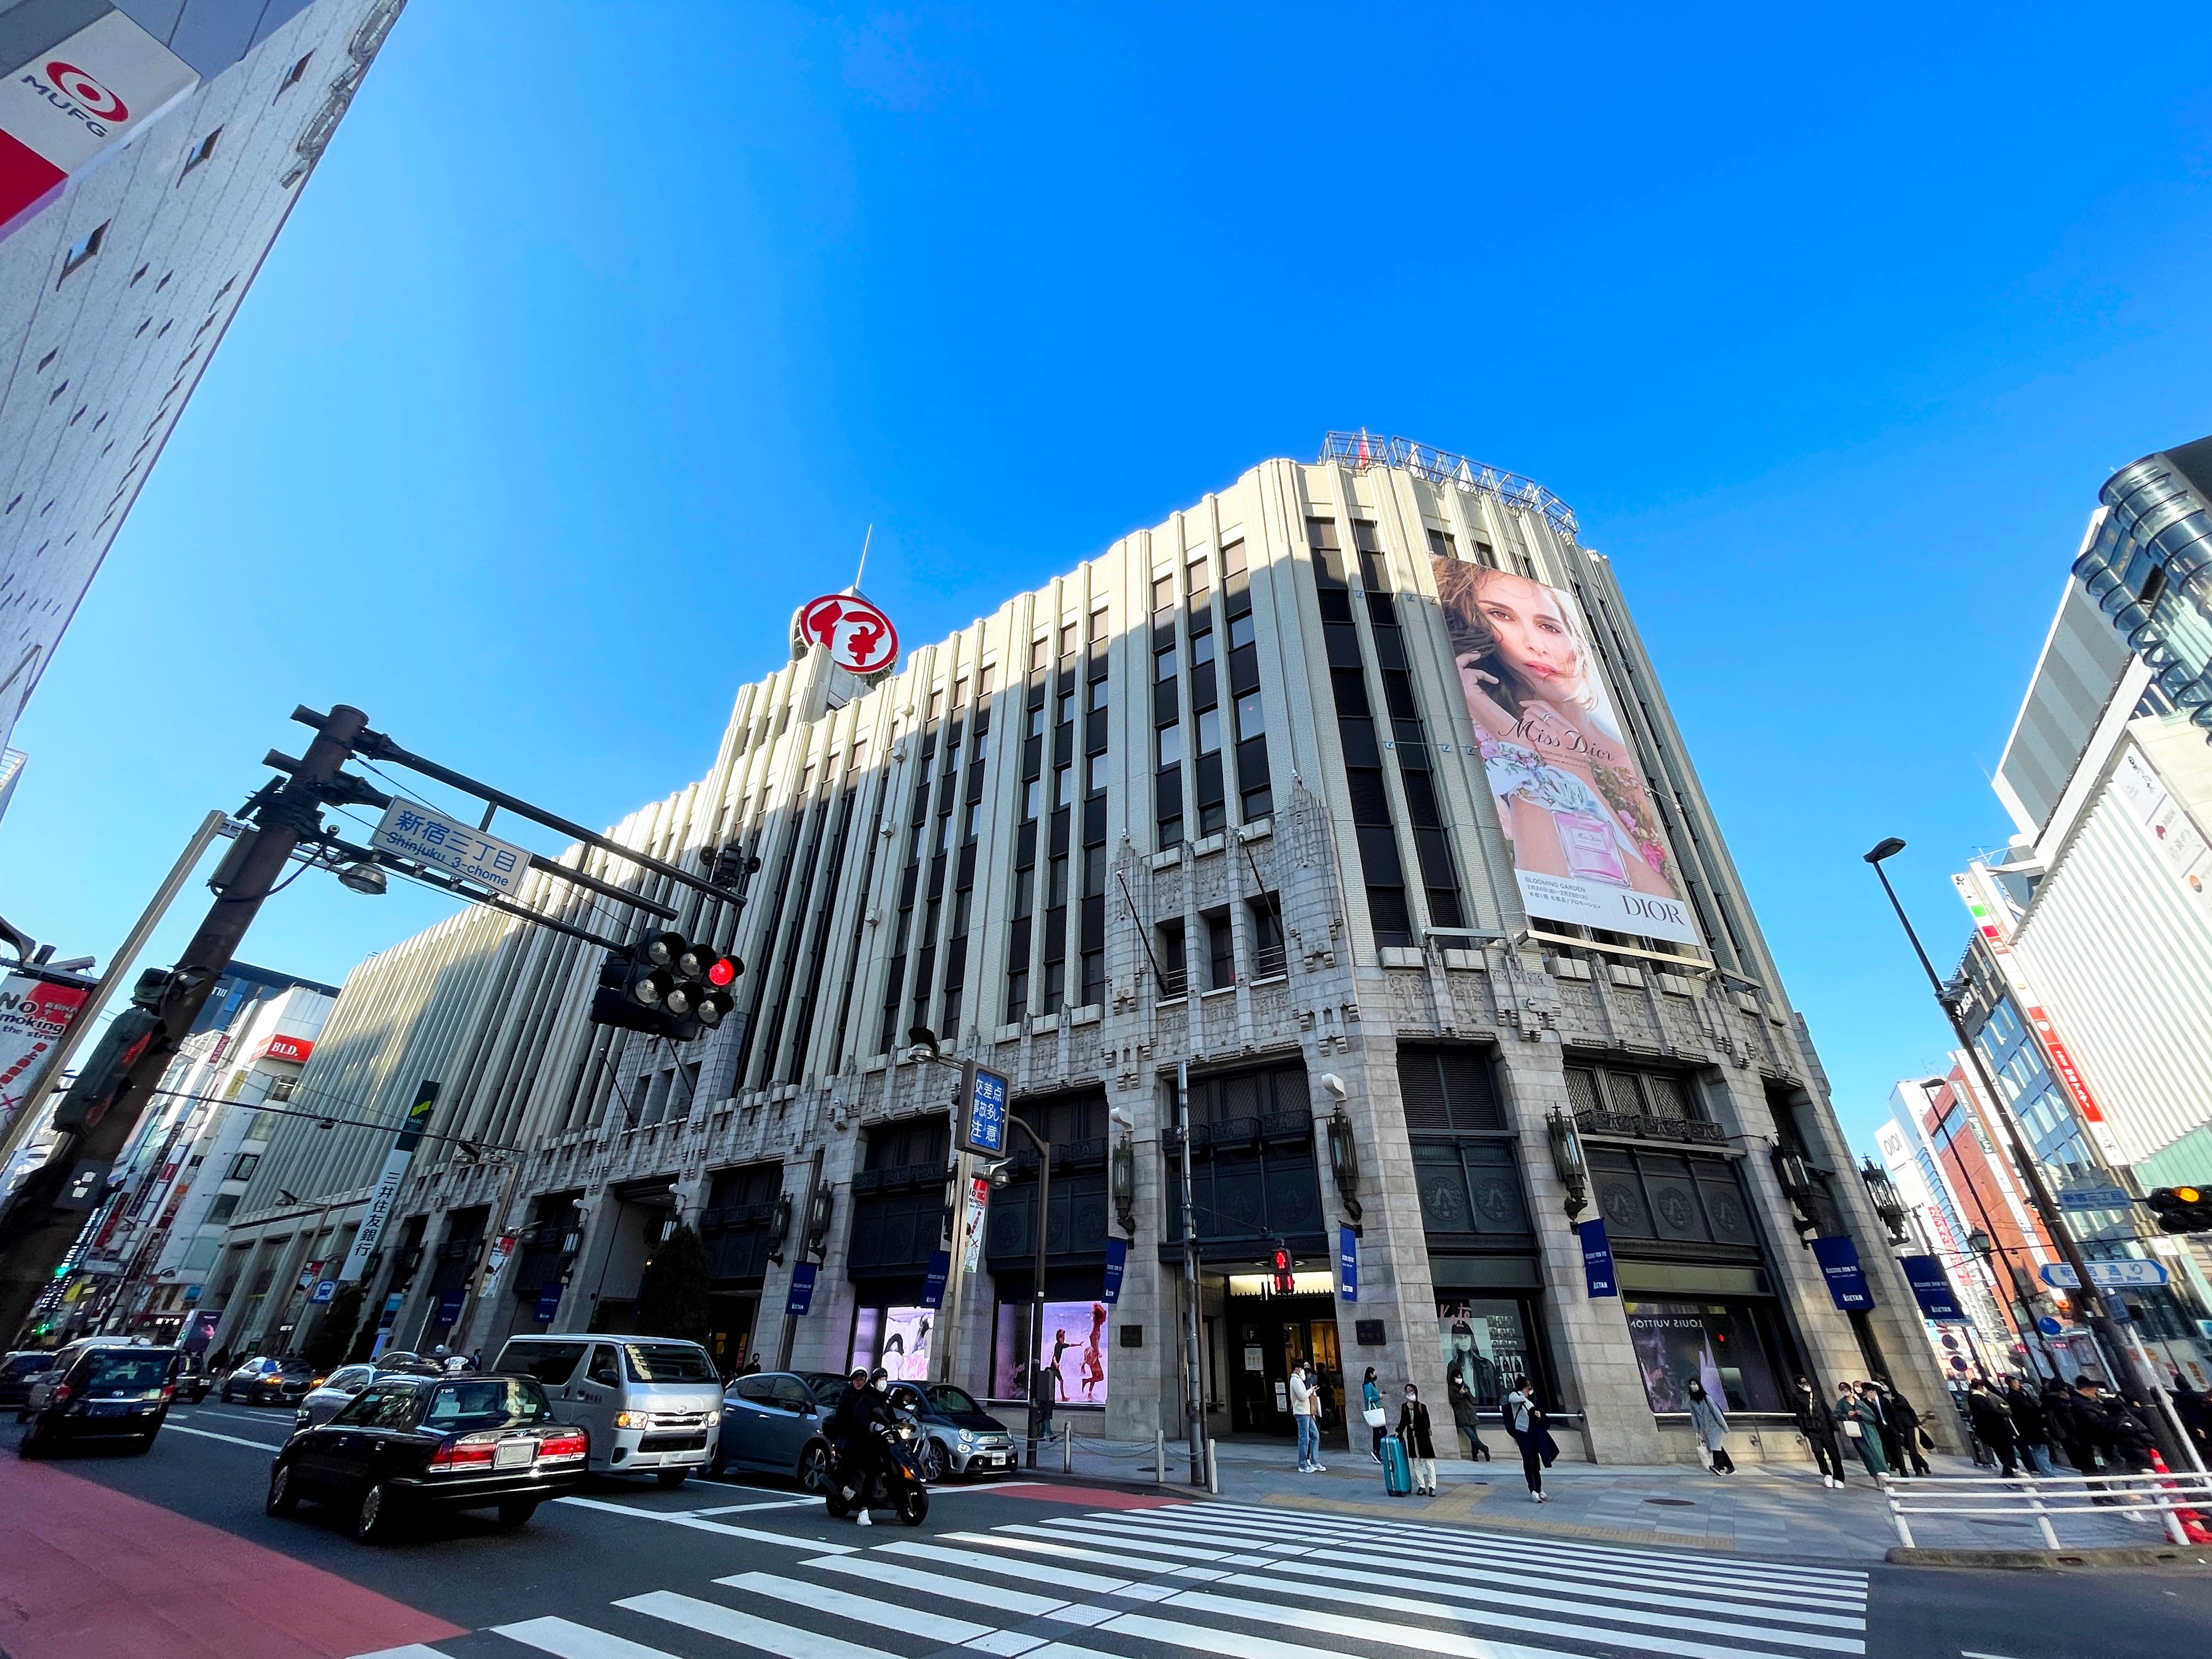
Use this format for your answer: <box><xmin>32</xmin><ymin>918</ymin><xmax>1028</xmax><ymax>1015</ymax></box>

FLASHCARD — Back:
<box><xmin>0</xmin><ymin>703</ymin><xmax>369</xmax><ymax>1342</ymax></box>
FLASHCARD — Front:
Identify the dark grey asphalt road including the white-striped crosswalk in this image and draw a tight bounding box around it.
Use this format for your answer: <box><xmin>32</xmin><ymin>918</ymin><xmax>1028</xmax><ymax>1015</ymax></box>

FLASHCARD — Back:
<box><xmin>17</xmin><ymin>1404</ymin><xmax>2212</xmax><ymax>1659</ymax></box>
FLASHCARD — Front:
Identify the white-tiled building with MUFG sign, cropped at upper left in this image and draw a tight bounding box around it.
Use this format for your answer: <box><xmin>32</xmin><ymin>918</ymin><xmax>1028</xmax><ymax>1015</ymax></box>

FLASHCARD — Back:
<box><xmin>0</xmin><ymin>0</ymin><xmax>405</xmax><ymax>748</ymax></box>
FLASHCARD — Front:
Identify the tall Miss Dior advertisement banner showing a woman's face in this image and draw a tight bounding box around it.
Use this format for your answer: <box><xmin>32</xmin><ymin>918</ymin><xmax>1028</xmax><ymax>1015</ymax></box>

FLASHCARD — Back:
<box><xmin>1429</xmin><ymin>557</ymin><xmax>1703</xmax><ymax>945</ymax></box>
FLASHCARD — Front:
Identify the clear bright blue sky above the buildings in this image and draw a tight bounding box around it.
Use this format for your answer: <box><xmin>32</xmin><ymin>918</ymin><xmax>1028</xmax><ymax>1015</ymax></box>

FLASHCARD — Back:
<box><xmin>0</xmin><ymin>0</ymin><xmax>2212</xmax><ymax>1139</ymax></box>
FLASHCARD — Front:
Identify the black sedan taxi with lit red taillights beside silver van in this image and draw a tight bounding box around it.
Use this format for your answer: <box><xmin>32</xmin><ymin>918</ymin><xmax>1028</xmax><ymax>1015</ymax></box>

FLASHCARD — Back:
<box><xmin>266</xmin><ymin>1376</ymin><xmax>591</xmax><ymax>1544</ymax></box>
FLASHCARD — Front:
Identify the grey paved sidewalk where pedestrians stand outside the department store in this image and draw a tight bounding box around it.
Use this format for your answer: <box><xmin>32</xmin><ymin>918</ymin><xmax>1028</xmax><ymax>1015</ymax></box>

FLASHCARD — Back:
<box><xmin>1037</xmin><ymin>1436</ymin><xmax>2163</xmax><ymax>1564</ymax></box>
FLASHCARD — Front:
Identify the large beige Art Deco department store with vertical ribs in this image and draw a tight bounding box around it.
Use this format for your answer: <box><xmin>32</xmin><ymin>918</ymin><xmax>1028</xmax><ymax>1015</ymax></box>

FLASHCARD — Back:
<box><xmin>220</xmin><ymin>438</ymin><xmax>1940</xmax><ymax>1460</ymax></box>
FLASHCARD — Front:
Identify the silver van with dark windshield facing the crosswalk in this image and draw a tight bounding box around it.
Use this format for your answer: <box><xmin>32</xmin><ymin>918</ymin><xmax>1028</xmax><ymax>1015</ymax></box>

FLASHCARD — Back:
<box><xmin>491</xmin><ymin>1334</ymin><xmax>721</xmax><ymax>1487</ymax></box>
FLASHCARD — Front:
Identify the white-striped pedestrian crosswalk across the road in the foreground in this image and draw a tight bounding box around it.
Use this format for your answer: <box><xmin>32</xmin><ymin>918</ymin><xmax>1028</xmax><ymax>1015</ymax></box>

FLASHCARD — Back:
<box><xmin>358</xmin><ymin>1502</ymin><xmax>1867</xmax><ymax>1659</ymax></box>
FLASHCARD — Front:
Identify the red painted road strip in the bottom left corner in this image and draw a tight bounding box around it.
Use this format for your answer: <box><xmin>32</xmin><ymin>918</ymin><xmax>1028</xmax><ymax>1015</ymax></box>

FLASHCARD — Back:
<box><xmin>0</xmin><ymin>1458</ymin><xmax>465</xmax><ymax>1659</ymax></box>
